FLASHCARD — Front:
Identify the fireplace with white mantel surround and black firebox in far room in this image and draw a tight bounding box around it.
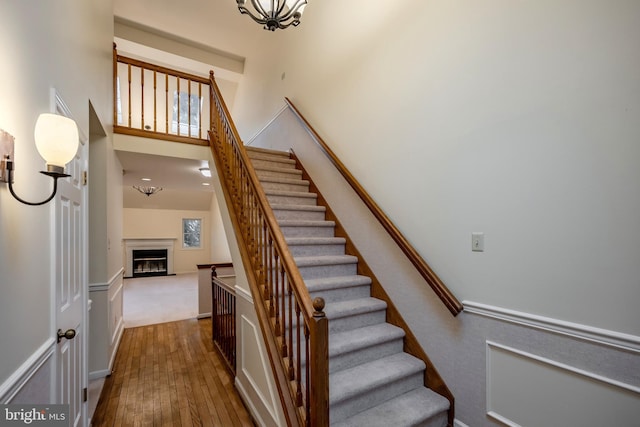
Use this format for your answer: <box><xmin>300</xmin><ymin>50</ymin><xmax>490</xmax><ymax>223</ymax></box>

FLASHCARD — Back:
<box><xmin>123</xmin><ymin>238</ymin><xmax>176</xmax><ymax>278</ymax></box>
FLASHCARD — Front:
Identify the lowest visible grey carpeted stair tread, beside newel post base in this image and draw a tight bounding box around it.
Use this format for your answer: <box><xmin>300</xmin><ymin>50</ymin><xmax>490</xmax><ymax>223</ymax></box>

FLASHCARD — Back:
<box><xmin>332</xmin><ymin>387</ymin><xmax>449</xmax><ymax>427</ymax></box>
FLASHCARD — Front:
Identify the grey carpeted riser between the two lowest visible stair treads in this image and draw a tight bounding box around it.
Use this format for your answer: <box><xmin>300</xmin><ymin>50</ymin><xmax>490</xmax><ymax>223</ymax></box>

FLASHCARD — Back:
<box><xmin>329</xmin><ymin>372</ymin><xmax>424</xmax><ymax>423</ymax></box>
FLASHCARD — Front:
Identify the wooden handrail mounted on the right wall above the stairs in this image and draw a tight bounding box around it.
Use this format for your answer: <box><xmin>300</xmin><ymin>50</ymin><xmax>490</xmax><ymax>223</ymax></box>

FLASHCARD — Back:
<box><xmin>285</xmin><ymin>98</ymin><xmax>464</xmax><ymax>316</ymax></box>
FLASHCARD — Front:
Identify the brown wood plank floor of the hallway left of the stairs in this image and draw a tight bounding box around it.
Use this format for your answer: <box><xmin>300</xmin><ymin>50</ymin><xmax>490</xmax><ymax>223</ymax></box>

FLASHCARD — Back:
<box><xmin>92</xmin><ymin>319</ymin><xmax>254</xmax><ymax>427</ymax></box>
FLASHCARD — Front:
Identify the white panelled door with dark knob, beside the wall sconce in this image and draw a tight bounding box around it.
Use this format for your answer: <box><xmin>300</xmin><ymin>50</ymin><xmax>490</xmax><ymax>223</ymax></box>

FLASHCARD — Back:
<box><xmin>53</xmin><ymin>101</ymin><xmax>88</xmax><ymax>426</ymax></box>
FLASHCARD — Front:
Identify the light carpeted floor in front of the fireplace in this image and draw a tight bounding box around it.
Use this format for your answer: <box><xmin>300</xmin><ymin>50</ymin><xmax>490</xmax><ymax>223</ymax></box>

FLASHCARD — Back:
<box><xmin>122</xmin><ymin>272</ymin><xmax>198</xmax><ymax>328</ymax></box>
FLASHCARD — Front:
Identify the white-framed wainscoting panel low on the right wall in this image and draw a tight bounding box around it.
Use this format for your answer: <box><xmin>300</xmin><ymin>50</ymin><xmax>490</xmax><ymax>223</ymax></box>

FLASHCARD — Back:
<box><xmin>487</xmin><ymin>341</ymin><xmax>640</xmax><ymax>427</ymax></box>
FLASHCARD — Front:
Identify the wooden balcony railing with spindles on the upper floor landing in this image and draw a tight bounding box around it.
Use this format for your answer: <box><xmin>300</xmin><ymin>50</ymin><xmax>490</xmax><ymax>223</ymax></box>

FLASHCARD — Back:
<box><xmin>113</xmin><ymin>45</ymin><xmax>210</xmax><ymax>146</ymax></box>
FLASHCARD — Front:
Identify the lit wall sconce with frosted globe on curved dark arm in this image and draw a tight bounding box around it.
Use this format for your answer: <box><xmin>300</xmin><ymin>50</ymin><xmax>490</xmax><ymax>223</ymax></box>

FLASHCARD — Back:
<box><xmin>0</xmin><ymin>113</ymin><xmax>79</xmax><ymax>206</ymax></box>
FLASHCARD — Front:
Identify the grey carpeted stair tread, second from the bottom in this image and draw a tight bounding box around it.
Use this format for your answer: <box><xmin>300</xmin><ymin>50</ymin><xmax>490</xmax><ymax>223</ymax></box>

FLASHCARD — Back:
<box><xmin>329</xmin><ymin>353</ymin><xmax>426</xmax><ymax>405</ymax></box>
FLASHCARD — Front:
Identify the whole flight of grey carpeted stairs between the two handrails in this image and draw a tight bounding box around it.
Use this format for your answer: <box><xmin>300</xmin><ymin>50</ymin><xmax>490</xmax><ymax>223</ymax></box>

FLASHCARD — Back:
<box><xmin>247</xmin><ymin>147</ymin><xmax>449</xmax><ymax>427</ymax></box>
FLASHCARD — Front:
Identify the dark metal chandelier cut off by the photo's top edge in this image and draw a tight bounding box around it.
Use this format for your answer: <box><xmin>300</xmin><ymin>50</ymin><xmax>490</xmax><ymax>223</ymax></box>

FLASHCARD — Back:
<box><xmin>236</xmin><ymin>0</ymin><xmax>307</xmax><ymax>31</ymax></box>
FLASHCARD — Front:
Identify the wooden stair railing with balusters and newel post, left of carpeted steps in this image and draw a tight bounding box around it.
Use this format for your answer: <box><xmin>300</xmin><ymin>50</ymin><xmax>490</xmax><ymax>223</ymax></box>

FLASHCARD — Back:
<box><xmin>209</xmin><ymin>72</ymin><xmax>329</xmax><ymax>426</ymax></box>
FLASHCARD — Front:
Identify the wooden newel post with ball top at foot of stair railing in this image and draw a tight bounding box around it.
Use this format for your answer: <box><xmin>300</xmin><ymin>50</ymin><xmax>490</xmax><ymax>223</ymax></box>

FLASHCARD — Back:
<box><xmin>307</xmin><ymin>297</ymin><xmax>329</xmax><ymax>427</ymax></box>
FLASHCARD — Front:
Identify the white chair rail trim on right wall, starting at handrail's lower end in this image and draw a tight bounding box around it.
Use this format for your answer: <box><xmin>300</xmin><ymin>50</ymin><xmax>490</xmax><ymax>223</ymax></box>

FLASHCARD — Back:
<box><xmin>462</xmin><ymin>301</ymin><xmax>640</xmax><ymax>353</ymax></box>
